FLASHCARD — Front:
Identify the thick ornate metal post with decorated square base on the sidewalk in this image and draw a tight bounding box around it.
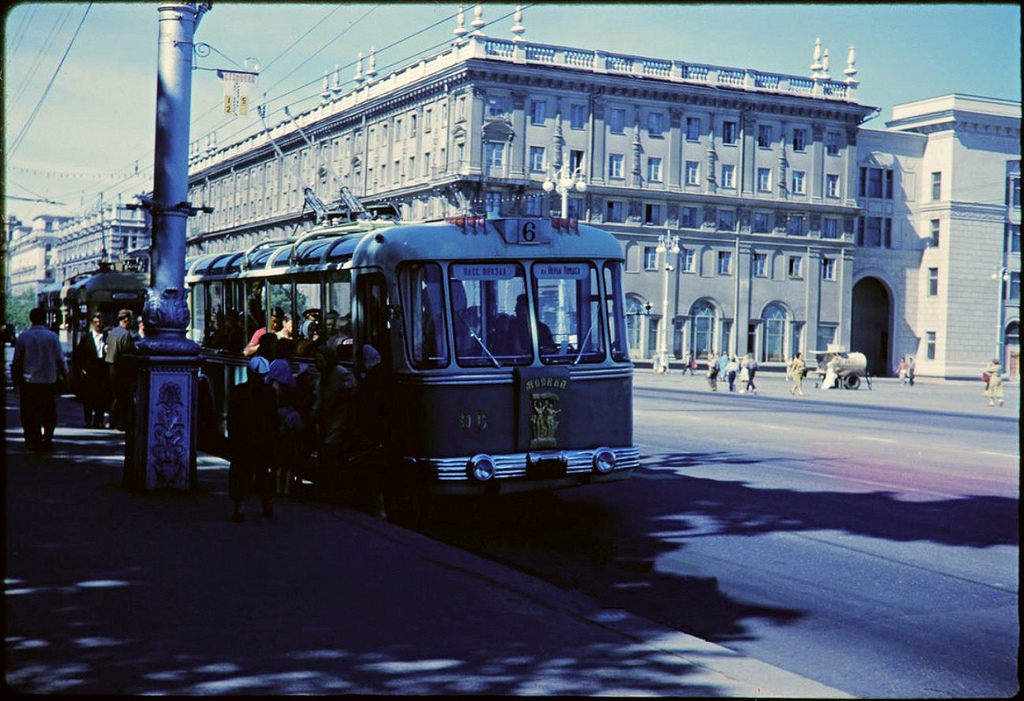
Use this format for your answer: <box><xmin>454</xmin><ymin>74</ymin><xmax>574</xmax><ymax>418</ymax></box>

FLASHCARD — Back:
<box><xmin>123</xmin><ymin>2</ymin><xmax>210</xmax><ymax>491</ymax></box>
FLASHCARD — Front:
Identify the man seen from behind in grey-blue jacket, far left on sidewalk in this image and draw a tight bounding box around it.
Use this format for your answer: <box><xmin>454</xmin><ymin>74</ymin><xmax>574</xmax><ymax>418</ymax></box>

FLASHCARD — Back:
<box><xmin>11</xmin><ymin>307</ymin><xmax>71</xmax><ymax>452</ymax></box>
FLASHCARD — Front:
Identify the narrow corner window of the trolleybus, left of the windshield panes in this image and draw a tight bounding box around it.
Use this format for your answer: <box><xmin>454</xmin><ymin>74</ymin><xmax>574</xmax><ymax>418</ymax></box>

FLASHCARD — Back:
<box><xmin>399</xmin><ymin>263</ymin><xmax>449</xmax><ymax>368</ymax></box>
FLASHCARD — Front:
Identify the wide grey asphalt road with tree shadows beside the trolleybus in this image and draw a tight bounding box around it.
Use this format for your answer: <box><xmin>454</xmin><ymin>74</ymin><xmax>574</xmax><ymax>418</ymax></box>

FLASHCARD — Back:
<box><xmin>413</xmin><ymin>375</ymin><xmax>1020</xmax><ymax>697</ymax></box>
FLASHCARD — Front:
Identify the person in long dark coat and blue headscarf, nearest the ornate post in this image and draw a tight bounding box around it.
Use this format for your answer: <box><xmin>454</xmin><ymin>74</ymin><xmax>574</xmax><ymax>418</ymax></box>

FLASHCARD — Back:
<box><xmin>227</xmin><ymin>355</ymin><xmax>278</xmax><ymax>523</ymax></box>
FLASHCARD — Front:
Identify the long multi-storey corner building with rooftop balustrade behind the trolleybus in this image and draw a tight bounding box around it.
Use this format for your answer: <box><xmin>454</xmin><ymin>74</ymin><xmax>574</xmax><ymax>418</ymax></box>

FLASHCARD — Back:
<box><xmin>182</xmin><ymin>21</ymin><xmax>872</xmax><ymax>374</ymax></box>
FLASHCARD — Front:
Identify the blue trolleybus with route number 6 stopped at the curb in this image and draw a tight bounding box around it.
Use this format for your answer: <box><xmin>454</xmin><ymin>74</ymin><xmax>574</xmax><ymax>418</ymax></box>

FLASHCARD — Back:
<box><xmin>186</xmin><ymin>217</ymin><xmax>639</xmax><ymax>515</ymax></box>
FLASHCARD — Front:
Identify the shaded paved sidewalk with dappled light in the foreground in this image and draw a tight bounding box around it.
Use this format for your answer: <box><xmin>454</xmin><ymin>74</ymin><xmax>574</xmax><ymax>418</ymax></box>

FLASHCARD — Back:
<box><xmin>4</xmin><ymin>388</ymin><xmax>845</xmax><ymax>698</ymax></box>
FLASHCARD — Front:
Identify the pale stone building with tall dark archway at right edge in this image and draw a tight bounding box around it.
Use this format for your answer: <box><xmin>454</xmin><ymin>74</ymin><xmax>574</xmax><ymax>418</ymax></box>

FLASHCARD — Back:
<box><xmin>852</xmin><ymin>94</ymin><xmax>1021</xmax><ymax>379</ymax></box>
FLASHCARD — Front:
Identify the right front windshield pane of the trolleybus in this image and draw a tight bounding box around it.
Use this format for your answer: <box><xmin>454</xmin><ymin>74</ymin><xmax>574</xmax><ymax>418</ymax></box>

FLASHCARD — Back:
<box><xmin>534</xmin><ymin>261</ymin><xmax>604</xmax><ymax>363</ymax></box>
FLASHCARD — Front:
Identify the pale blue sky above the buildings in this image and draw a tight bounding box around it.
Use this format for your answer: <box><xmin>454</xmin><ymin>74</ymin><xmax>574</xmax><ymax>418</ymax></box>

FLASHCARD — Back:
<box><xmin>3</xmin><ymin>2</ymin><xmax>1021</xmax><ymax>219</ymax></box>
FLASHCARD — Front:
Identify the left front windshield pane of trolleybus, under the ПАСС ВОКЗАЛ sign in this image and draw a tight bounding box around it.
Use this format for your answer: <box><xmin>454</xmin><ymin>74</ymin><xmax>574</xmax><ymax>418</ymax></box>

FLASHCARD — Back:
<box><xmin>449</xmin><ymin>261</ymin><xmax>532</xmax><ymax>367</ymax></box>
